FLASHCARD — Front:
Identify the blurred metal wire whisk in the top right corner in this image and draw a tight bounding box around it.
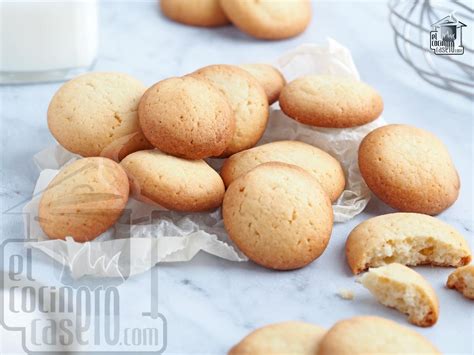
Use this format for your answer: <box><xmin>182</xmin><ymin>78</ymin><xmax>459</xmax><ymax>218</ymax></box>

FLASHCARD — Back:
<box><xmin>389</xmin><ymin>0</ymin><xmax>474</xmax><ymax>99</ymax></box>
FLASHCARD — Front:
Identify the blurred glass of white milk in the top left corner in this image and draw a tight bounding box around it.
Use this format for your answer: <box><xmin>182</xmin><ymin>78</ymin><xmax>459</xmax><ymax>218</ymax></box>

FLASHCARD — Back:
<box><xmin>0</xmin><ymin>0</ymin><xmax>98</xmax><ymax>84</ymax></box>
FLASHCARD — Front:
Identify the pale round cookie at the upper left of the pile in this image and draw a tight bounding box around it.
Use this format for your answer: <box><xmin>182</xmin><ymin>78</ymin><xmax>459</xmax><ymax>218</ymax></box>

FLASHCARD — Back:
<box><xmin>48</xmin><ymin>73</ymin><xmax>151</xmax><ymax>160</ymax></box>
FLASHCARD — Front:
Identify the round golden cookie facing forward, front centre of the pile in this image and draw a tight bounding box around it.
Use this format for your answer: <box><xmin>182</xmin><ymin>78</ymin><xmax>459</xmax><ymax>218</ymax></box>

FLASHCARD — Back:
<box><xmin>222</xmin><ymin>162</ymin><xmax>333</xmax><ymax>270</ymax></box>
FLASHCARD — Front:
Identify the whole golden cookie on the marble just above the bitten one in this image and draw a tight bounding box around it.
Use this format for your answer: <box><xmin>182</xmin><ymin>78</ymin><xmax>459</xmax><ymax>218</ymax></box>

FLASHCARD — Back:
<box><xmin>359</xmin><ymin>125</ymin><xmax>460</xmax><ymax>215</ymax></box>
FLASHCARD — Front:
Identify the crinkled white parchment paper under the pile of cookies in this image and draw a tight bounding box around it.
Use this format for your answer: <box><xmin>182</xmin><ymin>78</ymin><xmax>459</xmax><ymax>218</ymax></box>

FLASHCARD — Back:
<box><xmin>23</xmin><ymin>39</ymin><xmax>385</xmax><ymax>278</ymax></box>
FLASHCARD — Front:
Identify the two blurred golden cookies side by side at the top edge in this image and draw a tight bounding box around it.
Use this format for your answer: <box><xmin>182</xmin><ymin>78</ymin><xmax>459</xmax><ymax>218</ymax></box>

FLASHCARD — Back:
<box><xmin>160</xmin><ymin>0</ymin><xmax>311</xmax><ymax>40</ymax></box>
